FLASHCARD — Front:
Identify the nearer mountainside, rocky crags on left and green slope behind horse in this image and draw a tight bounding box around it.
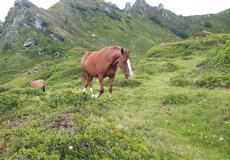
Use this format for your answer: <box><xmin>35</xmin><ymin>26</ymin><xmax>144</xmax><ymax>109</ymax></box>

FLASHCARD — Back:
<box><xmin>1</xmin><ymin>0</ymin><xmax>180</xmax><ymax>54</ymax></box>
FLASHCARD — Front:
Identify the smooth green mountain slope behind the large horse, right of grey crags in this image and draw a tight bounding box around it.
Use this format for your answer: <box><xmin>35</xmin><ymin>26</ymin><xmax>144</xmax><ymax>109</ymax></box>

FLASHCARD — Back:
<box><xmin>49</xmin><ymin>0</ymin><xmax>176</xmax><ymax>54</ymax></box>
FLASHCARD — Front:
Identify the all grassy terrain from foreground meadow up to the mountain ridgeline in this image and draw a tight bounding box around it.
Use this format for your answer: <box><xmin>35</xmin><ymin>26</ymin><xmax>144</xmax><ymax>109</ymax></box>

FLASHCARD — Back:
<box><xmin>0</xmin><ymin>0</ymin><xmax>230</xmax><ymax>160</ymax></box>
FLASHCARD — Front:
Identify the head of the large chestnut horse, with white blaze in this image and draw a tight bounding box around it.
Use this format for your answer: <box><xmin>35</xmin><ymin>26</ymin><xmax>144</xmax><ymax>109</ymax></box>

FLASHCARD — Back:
<box><xmin>118</xmin><ymin>48</ymin><xmax>133</xmax><ymax>79</ymax></box>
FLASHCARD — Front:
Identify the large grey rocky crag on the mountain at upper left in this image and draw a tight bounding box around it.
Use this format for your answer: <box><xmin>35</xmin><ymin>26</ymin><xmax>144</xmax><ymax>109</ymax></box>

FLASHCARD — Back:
<box><xmin>0</xmin><ymin>0</ymin><xmax>64</xmax><ymax>48</ymax></box>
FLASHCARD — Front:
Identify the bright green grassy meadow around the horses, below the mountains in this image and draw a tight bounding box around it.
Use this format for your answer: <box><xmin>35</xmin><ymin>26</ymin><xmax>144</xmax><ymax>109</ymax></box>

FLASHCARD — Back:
<box><xmin>0</xmin><ymin>34</ymin><xmax>230</xmax><ymax>160</ymax></box>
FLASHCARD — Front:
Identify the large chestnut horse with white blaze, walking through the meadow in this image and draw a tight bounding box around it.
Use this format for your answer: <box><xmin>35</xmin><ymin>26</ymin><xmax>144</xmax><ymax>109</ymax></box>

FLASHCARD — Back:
<box><xmin>81</xmin><ymin>47</ymin><xmax>133</xmax><ymax>98</ymax></box>
